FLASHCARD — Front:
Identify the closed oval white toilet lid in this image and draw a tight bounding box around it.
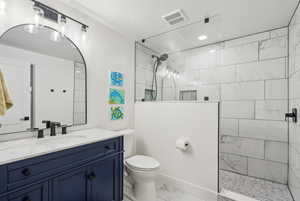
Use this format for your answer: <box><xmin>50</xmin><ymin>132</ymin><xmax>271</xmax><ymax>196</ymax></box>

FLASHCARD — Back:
<box><xmin>125</xmin><ymin>155</ymin><xmax>160</xmax><ymax>170</ymax></box>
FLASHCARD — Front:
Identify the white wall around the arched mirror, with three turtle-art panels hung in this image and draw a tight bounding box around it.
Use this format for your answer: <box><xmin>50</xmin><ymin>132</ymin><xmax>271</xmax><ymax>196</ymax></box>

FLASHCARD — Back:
<box><xmin>0</xmin><ymin>0</ymin><xmax>134</xmax><ymax>137</ymax></box>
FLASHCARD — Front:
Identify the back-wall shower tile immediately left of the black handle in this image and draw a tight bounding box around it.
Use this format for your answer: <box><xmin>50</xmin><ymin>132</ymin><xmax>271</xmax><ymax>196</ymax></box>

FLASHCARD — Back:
<box><xmin>255</xmin><ymin>100</ymin><xmax>288</xmax><ymax>120</ymax></box>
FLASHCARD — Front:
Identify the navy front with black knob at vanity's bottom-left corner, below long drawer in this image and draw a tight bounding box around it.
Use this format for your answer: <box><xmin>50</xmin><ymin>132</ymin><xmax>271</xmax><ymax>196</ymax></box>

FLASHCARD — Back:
<box><xmin>0</xmin><ymin>183</ymin><xmax>49</xmax><ymax>201</ymax></box>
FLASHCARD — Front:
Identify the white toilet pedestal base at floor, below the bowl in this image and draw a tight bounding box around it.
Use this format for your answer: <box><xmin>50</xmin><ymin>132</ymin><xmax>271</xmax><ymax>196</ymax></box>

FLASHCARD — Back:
<box><xmin>133</xmin><ymin>181</ymin><xmax>156</xmax><ymax>201</ymax></box>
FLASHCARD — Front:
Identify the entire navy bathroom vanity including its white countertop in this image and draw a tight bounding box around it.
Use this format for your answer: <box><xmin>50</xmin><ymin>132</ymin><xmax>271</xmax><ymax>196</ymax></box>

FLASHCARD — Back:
<box><xmin>0</xmin><ymin>129</ymin><xmax>128</xmax><ymax>201</ymax></box>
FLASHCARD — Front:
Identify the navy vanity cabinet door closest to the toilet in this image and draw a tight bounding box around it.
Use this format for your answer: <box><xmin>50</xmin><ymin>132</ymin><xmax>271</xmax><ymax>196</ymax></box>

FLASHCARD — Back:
<box><xmin>89</xmin><ymin>156</ymin><xmax>121</xmax><ymax>201</ymax></box>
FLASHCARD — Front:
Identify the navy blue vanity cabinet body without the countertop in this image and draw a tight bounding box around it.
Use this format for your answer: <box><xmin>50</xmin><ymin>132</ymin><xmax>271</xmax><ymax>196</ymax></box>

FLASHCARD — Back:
<box><xmin>0</xmin><ymin>137</ymin><xmax>123</xmax><ymax>201</ymax></box>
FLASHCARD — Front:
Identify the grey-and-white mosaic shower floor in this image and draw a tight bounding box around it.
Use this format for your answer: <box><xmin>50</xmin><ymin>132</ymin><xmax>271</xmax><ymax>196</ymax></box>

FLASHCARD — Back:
<box><xmin>220</xmin><ymin>171</ymin><xmax>293</xmax><ymax>201</ymax></box>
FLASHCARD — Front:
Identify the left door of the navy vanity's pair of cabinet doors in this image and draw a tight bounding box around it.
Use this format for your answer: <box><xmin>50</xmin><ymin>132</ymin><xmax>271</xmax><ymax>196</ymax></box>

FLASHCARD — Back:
<box><xmin>51</xmin><ymin>168</ymin><xmax>88</xmax><ymax>201</ymax></box>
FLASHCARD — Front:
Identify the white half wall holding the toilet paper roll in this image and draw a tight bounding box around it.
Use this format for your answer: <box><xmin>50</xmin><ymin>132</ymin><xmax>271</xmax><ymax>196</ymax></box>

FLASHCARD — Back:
<box><xmin>135</xmin><ymin>102</ymin><xmax>218</xmax><ymax>192</ymax></box>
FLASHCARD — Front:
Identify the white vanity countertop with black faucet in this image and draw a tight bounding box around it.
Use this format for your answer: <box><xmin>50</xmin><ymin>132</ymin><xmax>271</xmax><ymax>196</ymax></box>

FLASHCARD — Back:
<box><xmin>0</xmin><ymin>128</ymin><xmax>133</xmax><ymax>165</ymax></box>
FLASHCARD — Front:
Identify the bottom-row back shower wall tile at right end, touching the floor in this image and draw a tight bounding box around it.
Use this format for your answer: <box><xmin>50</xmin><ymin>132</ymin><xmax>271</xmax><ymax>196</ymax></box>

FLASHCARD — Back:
<box><xmin>248</xmin><ymin>158</ymin><xmax>287</xmax><ymax>184</ymax></box>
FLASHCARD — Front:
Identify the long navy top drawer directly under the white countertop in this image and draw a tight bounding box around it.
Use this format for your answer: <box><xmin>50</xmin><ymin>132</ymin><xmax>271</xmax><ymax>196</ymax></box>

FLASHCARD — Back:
<box><xmin>7</xmin><ymin>138</ymin><xmax>122</xmax><ymax>190</ymax></box>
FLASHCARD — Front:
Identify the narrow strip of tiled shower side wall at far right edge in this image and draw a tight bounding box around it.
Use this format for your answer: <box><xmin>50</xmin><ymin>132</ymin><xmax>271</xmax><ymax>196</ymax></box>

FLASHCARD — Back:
<box><xmin>288</xmin><ymin>3</ymin><xmax>300</xmax><ymax>201</ymax></box>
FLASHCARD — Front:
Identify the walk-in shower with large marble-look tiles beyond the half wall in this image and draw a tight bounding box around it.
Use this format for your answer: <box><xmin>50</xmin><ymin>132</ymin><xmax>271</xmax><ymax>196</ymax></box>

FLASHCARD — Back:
<box><xmin>136</xmin><ymin>15</ymin><xmax>300</xmax><ymax>201</ymax></box>
